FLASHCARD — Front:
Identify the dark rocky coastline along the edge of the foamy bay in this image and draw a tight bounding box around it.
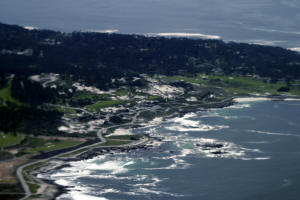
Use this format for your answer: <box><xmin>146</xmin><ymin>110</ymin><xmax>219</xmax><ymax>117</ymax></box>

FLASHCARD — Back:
<box><xmin>25</xmin><ymin>95</ymin><xmax>300</xmax><ymax>200</ymax></box>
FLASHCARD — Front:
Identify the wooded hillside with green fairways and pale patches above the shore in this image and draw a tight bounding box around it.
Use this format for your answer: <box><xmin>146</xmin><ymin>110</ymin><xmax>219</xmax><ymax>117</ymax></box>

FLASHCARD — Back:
<box><xmin>0</xmin><ymin>21</ymin><xmax>300</xmax><ymax>135</ymax></box>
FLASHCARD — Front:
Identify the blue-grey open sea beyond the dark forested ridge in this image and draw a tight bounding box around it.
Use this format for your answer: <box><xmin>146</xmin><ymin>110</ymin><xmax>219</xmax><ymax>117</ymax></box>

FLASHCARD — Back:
<box><xmin>0</xmin><ymin>0</ymin><xmax>300</xmax><ymax>50</ymax></box>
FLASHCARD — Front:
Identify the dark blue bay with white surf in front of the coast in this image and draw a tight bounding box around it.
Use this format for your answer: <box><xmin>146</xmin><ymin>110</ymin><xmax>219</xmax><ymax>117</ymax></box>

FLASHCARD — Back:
<box><xmin>44</xmin><ymin>101</ymin><xmax>300</xmax><ymax>200</ymax></box>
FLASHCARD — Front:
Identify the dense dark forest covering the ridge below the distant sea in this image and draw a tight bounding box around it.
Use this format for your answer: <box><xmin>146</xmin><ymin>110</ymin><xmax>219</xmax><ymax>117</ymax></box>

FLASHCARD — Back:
<box><xmin>0</xmin><ymin>24</ymin><xmax>300</xmax><ymax>89</ymax></box>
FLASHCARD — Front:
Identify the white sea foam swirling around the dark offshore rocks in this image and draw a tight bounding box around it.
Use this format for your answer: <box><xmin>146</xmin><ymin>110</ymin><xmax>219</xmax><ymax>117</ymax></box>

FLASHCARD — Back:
<box><xmin>147</xmin><ymin>133</ymin><xmax>262</xmax><ymax>170</ymax></box>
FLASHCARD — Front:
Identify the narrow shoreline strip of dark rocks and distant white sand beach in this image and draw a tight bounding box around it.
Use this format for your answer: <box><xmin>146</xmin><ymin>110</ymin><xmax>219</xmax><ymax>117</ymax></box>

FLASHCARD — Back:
<box><xmin>21</xmin><ymin>95</ymin><xmax>300</xmax><ymax>200</ymax></box>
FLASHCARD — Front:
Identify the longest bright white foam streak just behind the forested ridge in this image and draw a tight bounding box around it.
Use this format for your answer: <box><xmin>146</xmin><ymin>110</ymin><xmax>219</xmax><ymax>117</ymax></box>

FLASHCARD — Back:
<box><xmin>147</xmin><ymin>32</ymin><xmax>221</xmax><ymax>40</ymax></box>
